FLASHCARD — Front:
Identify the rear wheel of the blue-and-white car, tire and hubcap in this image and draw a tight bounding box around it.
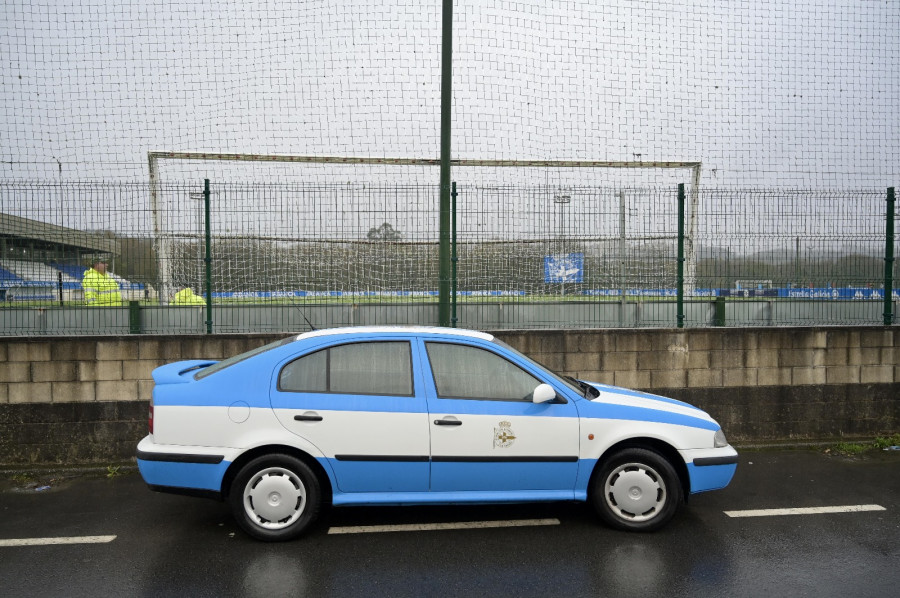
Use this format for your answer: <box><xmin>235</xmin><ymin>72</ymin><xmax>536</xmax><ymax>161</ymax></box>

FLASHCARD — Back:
<box><xmin>229</xmin><ymin>454</ymin><xmax>322</xmax><ymax>542</ymax></box>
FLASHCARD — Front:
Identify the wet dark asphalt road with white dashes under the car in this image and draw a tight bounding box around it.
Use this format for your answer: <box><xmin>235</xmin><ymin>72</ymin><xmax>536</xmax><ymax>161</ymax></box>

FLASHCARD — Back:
<box><xmin>0</xmin><ymin>450</ymin><xmax>900</xmax><ymax>598</ymax></box>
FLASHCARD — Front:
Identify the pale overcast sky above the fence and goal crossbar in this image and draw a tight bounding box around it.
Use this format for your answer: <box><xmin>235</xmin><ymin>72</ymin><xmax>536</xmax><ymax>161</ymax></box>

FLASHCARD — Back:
<box><xmin>0</xmin><ymin>0</ymin><xmax>900</xmax><ymax>187</ymax></box>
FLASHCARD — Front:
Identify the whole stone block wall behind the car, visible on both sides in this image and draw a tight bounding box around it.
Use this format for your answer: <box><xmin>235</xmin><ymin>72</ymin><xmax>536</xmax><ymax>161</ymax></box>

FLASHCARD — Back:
<box><xmin>0</xmin><ymin>327</ymin><xmax>900</xmax><ymax>463</ymax></box>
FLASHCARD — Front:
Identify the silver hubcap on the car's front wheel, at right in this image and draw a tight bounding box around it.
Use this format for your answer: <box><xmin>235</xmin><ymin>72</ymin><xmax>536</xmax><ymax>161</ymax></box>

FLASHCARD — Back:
<box><xmin>604</xmin><ymin>463</ymin><xmax>667</xmax><ymax>521</ymax></box>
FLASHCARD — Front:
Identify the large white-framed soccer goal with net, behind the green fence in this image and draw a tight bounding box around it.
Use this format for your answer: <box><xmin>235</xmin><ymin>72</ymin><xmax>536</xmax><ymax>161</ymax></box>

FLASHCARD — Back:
<box><xmin>149</xmin><ymin>152</ymin><xmax>701</xmax><ymax>304</ymax></box>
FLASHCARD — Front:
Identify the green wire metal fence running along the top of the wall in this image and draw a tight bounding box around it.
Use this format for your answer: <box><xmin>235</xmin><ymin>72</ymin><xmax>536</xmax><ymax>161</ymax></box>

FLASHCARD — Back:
<box><xmin>0</xmin><ymin>181</ymin><xmax>898</xmax><ymax>335</ymax></box>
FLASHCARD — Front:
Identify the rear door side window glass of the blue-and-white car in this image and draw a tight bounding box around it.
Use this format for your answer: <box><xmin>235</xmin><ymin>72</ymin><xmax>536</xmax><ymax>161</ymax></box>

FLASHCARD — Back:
<box><xmin>278</xmin><ymin>341</ymin><xmax>413</xmax><ymax>397</ymax></box>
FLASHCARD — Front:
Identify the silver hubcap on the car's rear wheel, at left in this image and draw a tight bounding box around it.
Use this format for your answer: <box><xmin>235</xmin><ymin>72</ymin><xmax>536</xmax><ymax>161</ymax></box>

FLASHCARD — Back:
<box><xmin>244</xmin><ymin>467</ymin><xmax>306</xmax><ymax>529</ymax></box>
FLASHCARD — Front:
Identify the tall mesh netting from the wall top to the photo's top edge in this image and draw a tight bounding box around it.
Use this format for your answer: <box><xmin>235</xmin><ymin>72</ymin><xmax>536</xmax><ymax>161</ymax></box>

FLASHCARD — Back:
<box><xmin>0</xmin><ymin>0</ymin><xmax>900</xmax><ymax>334</ymax></box>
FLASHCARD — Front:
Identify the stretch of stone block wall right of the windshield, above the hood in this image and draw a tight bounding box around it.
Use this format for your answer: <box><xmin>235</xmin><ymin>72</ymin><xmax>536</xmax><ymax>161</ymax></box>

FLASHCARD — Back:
<box><xmin>497</xmin><ymin>327</ymin><xmax>900</xmax><ymax>443</ymax></box>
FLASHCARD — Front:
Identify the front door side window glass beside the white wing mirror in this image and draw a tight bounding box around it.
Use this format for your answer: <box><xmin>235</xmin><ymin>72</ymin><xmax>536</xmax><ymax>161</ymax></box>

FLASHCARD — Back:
<box><xmin>425</xmin><ymin>342</ymin><xmax>541</xmax><ymax>401</ymax></box>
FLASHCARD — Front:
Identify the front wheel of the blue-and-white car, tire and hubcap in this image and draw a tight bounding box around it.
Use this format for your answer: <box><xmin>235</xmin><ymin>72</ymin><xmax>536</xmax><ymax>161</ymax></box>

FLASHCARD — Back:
<box><xmin>591</xmin><ymin>448</ymin><xmax>684</xmax><ymax>532</ymax></box>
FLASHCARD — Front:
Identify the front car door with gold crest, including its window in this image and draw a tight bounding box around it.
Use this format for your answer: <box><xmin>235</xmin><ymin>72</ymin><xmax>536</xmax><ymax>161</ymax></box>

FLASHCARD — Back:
<box><xmin>420</xmin><ymin>340</ymin><xmax>579</xmax><ymax>492</ymax></box>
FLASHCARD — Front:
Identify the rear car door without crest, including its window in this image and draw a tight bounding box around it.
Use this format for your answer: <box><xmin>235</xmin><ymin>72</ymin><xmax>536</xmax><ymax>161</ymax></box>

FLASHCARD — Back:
<box><xmin>271</xmin><ymin>338</ymin><xmax>429</xmax><ymax>492</ymax></box>
